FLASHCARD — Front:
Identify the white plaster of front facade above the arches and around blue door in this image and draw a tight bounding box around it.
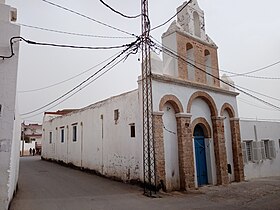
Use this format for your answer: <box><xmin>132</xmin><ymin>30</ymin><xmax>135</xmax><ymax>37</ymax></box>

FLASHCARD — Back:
<box><xmin>153</xmin><ymin>80</ymin><xmax>238</xmax><ymax>185</ymax></box>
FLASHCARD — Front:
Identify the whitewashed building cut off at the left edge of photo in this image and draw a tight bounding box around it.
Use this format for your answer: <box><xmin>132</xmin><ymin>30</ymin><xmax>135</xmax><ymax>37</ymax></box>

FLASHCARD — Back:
<box><xmin>0</xmin><ymin>0</ymin><xmax>20</xmax><ymax>210</ymax></box>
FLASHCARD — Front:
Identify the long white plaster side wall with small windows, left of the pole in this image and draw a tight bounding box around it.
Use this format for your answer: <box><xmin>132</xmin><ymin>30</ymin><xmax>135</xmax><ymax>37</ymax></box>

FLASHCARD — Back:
<box><xmin>42</xmin><ymin>90</ymin><xmax>142</xmax><ymax>181</ymax></box>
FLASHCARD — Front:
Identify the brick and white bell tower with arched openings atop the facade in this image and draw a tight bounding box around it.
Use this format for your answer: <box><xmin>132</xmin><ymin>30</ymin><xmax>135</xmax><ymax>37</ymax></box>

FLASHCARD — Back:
<box><xmin>162</xmin><ymin>0</ymin><xmax>220</xmax><ymax>87</ymax></box>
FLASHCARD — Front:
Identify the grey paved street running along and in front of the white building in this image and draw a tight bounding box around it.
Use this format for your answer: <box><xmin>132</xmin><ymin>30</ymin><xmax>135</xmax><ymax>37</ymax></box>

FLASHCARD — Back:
<box><xmin>10</xmin><ymin>156</ymin><xmax>280</xmax><ymax>210</ymax></box>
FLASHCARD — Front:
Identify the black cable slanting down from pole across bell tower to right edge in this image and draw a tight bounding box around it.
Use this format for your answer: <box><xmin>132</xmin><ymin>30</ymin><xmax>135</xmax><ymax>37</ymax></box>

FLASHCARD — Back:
<box><xmin>152</xmin><ymin>43</ymin><xmax>280</xmax><ymax>111</ymax></box>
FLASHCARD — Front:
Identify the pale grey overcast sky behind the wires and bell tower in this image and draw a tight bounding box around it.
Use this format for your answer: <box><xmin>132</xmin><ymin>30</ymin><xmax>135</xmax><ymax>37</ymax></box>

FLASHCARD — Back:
<box><xmin>6</xmin><ymin>0</ymin><xmax>280</xmax><ymax>123</ymax></box>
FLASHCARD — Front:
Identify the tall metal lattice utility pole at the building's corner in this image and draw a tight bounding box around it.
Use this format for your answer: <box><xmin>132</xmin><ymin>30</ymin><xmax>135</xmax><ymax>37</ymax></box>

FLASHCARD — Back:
<box><xmin>141</xmin><ymin>0</ymin><xmax>156</xmax><ymax>197</ymax></box>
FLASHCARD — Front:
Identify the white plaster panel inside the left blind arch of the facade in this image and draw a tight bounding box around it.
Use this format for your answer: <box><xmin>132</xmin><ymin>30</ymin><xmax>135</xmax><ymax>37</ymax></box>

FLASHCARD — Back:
<box><xmin>162</xmin><ymin>103</ymin><xmax>180</xmax><ymax>190</ymax></box>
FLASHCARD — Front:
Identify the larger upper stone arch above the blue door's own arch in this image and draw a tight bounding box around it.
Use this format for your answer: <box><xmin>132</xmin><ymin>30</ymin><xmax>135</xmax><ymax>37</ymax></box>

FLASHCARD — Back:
<box><xmin>187</xmin><ymin>91</ymin><xmax>218</xmax><ymax>117</ymax></box>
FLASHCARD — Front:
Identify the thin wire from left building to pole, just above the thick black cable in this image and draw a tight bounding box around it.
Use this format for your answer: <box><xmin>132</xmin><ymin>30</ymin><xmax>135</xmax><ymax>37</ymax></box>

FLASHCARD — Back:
<box><xmin>19</xmin><ymin>23</ymin><xmax>134</xmax><ymax>39</ymax></box>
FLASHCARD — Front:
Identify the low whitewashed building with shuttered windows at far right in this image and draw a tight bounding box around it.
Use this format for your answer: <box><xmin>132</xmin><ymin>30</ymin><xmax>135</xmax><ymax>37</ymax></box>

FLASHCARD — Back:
<box><xmin>240</xmin><ymin>120</ymin><xmax>280</xmax><ymax>179</ymax></box>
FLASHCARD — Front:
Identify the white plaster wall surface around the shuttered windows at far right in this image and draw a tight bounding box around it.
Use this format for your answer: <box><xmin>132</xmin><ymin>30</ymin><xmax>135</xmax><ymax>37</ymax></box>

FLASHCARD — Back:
<box><xmin>240</xmin><ymin>120</ymin><xmax>280</xmax><ymax>180</ymax></box>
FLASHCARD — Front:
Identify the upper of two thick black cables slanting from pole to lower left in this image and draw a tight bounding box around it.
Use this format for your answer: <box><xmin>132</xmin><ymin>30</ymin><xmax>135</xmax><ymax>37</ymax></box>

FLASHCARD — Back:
<box><xmin>21</xmin><ymin>38</ymin><xmax>139</xmax><ymax>116</ymax></box>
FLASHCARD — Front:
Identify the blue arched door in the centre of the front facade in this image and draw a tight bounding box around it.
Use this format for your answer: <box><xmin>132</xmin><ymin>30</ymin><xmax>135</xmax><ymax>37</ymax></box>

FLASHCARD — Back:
<box><xmin>193</xmin><ymin>125</ymin><xmax>208</xmax><ymax>186</ymax></box>
